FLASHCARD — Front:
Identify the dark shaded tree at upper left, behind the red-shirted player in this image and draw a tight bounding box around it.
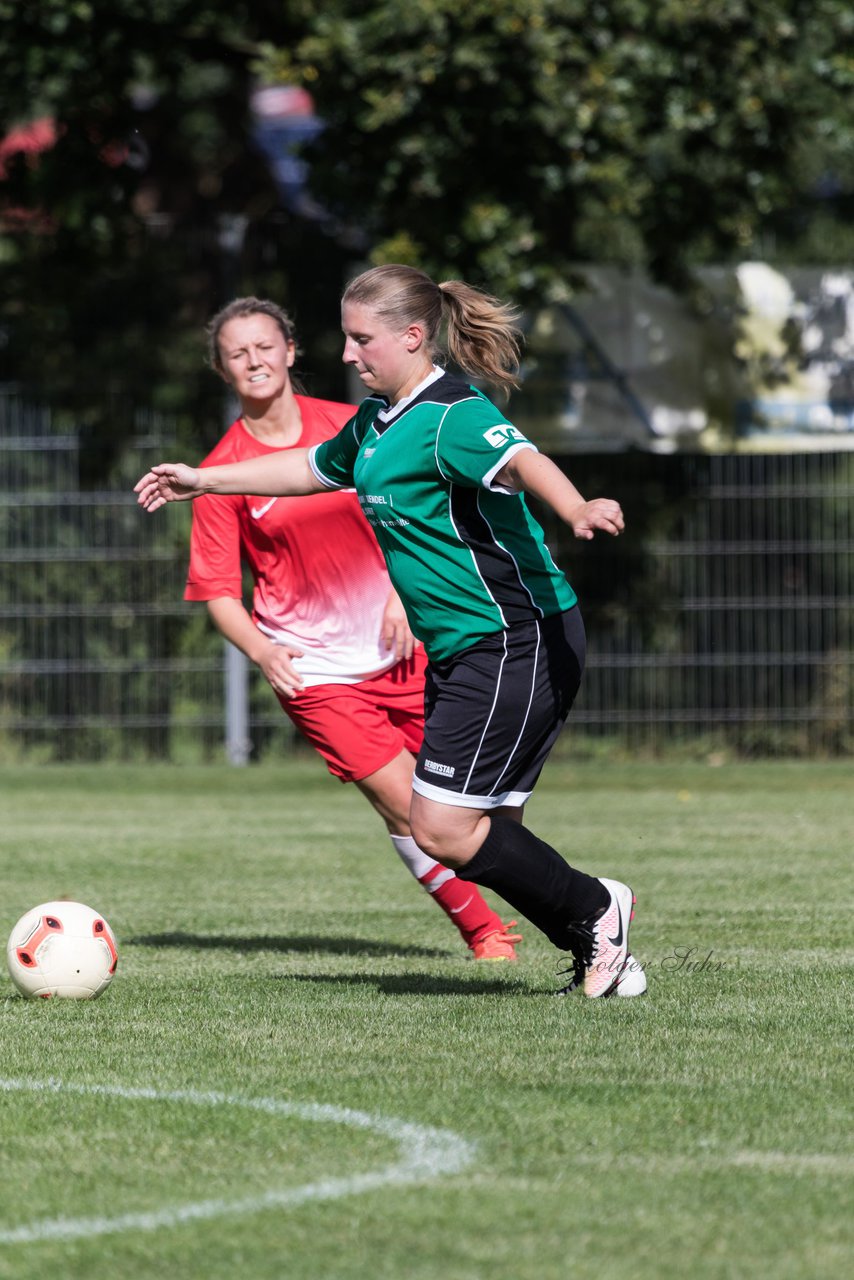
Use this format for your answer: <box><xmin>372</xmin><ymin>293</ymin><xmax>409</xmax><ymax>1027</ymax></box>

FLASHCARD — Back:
<box><xmin>0</xmin><ymin>0</ymin><xmax>341</xmax><ymax>463</ymax></box>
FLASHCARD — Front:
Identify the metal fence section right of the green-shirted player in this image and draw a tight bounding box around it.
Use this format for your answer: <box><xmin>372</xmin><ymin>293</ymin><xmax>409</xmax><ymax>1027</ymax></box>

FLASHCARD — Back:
<box><xmin>560</xmin><ymin>453</ymin><xmax>854</xmax><ymax>755</ymax></box>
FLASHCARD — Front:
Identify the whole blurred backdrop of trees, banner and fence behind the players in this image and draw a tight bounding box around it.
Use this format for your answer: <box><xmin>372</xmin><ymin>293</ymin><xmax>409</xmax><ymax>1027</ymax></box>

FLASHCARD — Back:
<box><xmin>0</xmin><ymin>0</ymin><xmax>854</xmax><ymax>764</ymax></box>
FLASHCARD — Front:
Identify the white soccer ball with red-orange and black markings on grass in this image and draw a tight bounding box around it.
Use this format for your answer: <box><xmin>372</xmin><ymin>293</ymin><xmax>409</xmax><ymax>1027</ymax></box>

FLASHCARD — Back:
<box><xmin>6</xmin><ymin>902</ymin><xmax>119</xmax><ymax>1000</ymax></box>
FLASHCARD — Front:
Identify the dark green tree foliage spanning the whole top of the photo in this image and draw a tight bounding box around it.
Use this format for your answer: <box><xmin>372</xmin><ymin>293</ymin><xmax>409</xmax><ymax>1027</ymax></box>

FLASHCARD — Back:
<box><xmin>0</xmin><ymin>0</ymin><xmax>854</xmax><ymax>471</ymax></box>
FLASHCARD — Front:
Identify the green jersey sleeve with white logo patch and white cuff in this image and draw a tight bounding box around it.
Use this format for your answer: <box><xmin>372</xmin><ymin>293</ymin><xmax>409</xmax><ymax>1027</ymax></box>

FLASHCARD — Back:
<box><xmin>435</xmin><ymin>398</ymin><xmax>536</xmax><ymax>493</ymax></box>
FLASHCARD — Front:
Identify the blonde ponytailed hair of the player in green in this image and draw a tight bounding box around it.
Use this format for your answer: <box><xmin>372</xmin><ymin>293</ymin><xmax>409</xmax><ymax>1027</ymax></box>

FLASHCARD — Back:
<box><xmin>342</xmin><ymin>264</ymin><xmax>522</xmax><ymax>389</ymax></box>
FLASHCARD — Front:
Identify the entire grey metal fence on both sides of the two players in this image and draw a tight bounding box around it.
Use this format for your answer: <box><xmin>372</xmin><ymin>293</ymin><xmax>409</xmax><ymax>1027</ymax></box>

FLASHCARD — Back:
<box><xmin>0</xmin><ymin>392</ymin><xmax>854</xmax><ymax>760</ymax></box>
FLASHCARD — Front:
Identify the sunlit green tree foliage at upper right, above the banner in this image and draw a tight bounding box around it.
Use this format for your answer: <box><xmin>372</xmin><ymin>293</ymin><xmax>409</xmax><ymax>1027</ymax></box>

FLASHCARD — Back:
<box><xmin>263</xmin><ymin>0</ymin><xmax>854</xmax><ymax>296</ymax></box>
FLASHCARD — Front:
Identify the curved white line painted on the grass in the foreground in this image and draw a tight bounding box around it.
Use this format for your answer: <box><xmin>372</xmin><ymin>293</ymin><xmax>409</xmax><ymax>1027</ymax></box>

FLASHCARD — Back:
<box><xmin>0</xmin><ymin>1079</ymin><xmax>475</xmax><ymax>1244</ymax></box>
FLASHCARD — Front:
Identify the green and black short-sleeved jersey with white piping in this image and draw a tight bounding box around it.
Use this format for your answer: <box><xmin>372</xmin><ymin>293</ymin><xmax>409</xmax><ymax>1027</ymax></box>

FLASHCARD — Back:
<box><xmin>310</xmin><ymin>369</ymin><xmax>576</xmax><ymax>662</ymax></box>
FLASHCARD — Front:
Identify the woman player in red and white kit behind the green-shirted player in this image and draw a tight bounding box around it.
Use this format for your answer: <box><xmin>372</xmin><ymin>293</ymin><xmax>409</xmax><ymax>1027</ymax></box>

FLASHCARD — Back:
<box><xmin>184</xmin><ymin>298</ymin><xmax>519</xmax><ymax>960</ymax></box>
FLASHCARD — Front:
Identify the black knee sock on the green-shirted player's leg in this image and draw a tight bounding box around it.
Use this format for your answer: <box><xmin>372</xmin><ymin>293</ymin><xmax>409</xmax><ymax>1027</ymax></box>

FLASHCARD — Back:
<box><xmin>457</xmin><ymin>817</ymin><xmax>611</xmax><ymax>950</ymax></box>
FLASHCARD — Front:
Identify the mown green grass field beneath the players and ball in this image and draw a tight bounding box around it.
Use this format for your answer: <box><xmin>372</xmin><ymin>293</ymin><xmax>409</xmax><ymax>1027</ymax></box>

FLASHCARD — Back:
<box><xmin>0</xmin><ymin>760</ymin><xmax>854</xmax><ymax>1280</ymax></box>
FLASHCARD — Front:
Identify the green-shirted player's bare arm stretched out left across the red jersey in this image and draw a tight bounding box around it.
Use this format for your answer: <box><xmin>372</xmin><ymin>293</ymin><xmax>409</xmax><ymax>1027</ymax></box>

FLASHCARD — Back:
<box><xmin>133</xmin><ymin>449</ymin><xmax>328</xmax><ymax>511</ymax></box>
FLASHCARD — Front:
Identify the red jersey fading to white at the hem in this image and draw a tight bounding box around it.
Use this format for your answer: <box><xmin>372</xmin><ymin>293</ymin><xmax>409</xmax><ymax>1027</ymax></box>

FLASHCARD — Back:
<box><xmin>184</xmin><ymin>396</ymin><xmax>397</xmax><ymax>686</ymax></box>
